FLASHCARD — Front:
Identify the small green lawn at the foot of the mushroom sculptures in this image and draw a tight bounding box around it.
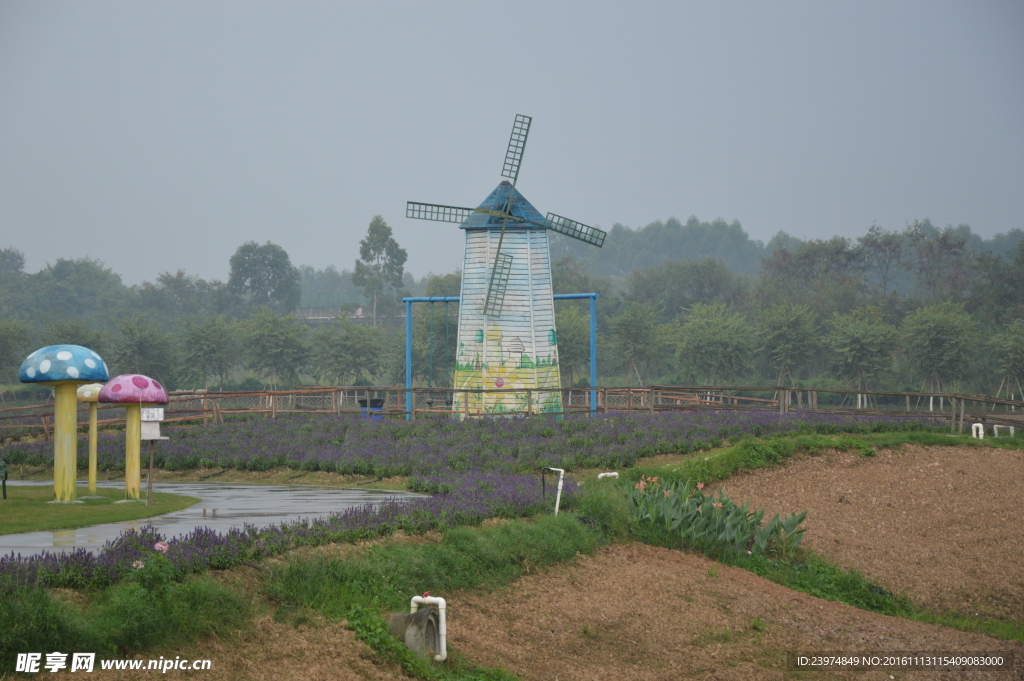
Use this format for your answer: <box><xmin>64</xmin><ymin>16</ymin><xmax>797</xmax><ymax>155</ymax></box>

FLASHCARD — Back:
<box><xmin>0</xmin><ymin>484</ymin><xmax>200</xmax><ymax>535</ymax></box>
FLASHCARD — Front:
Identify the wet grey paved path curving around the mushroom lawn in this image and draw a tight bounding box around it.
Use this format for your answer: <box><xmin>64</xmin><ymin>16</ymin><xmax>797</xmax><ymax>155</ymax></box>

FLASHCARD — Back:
<box><xmin>0</xmin><ymin>480</ymin><xmax>421</xmax><ymax>556</ymax></box>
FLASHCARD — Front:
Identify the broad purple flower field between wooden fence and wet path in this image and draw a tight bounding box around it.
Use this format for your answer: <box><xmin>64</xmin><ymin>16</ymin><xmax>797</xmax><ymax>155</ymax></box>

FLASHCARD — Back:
<box><xmin>0</xmin><ymin>405</ymin><xmax>941</xmax><ymax>477</ymax></box>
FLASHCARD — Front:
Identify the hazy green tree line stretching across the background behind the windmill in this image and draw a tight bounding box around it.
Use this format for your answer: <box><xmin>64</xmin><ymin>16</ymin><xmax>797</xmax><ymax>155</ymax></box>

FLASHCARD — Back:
<box><xmin>0</xmin><ymin>216</ymin><xmax>1024</xmax><ymax>392</ymax></box>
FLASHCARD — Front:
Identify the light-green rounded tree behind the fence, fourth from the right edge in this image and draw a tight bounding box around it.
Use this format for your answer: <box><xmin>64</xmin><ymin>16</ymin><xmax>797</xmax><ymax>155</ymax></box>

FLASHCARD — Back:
<box><xmin>755</xmin><ymin>303</ymin><xmax>817</xmax><ymax>385</ymax></box>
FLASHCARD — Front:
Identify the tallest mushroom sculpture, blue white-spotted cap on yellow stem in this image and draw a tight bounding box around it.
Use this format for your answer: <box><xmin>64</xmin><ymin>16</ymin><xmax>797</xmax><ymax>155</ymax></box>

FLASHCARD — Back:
<box><xmin>19</xmin><ymin>345</ymin><xmax>108</xmax><ymax>503</ymax></box>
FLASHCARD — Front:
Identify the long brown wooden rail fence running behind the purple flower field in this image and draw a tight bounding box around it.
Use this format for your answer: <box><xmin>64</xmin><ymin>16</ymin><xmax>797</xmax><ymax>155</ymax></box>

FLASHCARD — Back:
<box><xmin>0</xmin><ymin>385</ymin><xmax>1024</xmax><ymax>439</ymax></box>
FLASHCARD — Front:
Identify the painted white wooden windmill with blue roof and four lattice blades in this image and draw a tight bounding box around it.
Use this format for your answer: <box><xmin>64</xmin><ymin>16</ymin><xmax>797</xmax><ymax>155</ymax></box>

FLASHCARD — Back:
<box><xmin>406</xmin><ymin>115</ymin><xmax>605</xmax><ymax>414</ymax></box>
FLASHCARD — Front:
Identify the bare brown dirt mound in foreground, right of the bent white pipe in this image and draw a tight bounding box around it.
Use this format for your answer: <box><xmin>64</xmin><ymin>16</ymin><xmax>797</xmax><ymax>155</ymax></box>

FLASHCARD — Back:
<box><xmin>450</xmin><ymin>544</ymin><xmax>1024</xmax><ymax>681</ymax></box>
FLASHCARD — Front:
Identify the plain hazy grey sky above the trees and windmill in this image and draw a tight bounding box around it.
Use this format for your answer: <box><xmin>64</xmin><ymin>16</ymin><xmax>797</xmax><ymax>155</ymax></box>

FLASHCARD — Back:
<box><xmin>0</xmin><ymin>0</ymin><xmax>1024</xmax><ymax>284</ymax></box>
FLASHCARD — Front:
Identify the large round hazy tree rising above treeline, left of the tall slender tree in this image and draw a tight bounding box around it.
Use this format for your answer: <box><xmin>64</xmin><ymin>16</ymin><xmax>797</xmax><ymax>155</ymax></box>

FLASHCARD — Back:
<box><xmin>227</xmin><ymin>242</ymin><xmax>302</xmax><ymax>313</ymax></box>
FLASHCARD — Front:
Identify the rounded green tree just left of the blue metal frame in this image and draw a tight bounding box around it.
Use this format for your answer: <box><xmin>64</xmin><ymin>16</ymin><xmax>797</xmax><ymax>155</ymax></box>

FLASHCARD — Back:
<box><xmin>311</xmin><ymin>320</ymin><xmax>385</xmax><ymax>385</ymax></box>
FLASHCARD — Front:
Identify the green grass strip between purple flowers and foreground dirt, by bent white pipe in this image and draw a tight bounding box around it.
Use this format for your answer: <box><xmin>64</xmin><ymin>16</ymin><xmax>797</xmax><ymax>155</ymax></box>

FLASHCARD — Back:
<box><xmin>267</xmin><ymin>514</ymin><xmax>601</xmax><ymax>681</ymax></box>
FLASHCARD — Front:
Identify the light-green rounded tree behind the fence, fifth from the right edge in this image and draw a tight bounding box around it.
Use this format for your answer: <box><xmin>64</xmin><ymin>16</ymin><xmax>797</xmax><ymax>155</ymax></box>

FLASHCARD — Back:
<box><xmin>678</xmin><ymin>303</ymin><xmax>754</xmax><ymax>385</ymax></box>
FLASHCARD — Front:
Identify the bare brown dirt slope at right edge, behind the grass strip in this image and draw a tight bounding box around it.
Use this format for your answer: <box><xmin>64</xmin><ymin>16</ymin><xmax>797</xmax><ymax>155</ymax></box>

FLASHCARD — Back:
<box><xmin>720</xmin><ymin>444</ymin><xmax>1024</xmax><ymax>622</ymax></box>
